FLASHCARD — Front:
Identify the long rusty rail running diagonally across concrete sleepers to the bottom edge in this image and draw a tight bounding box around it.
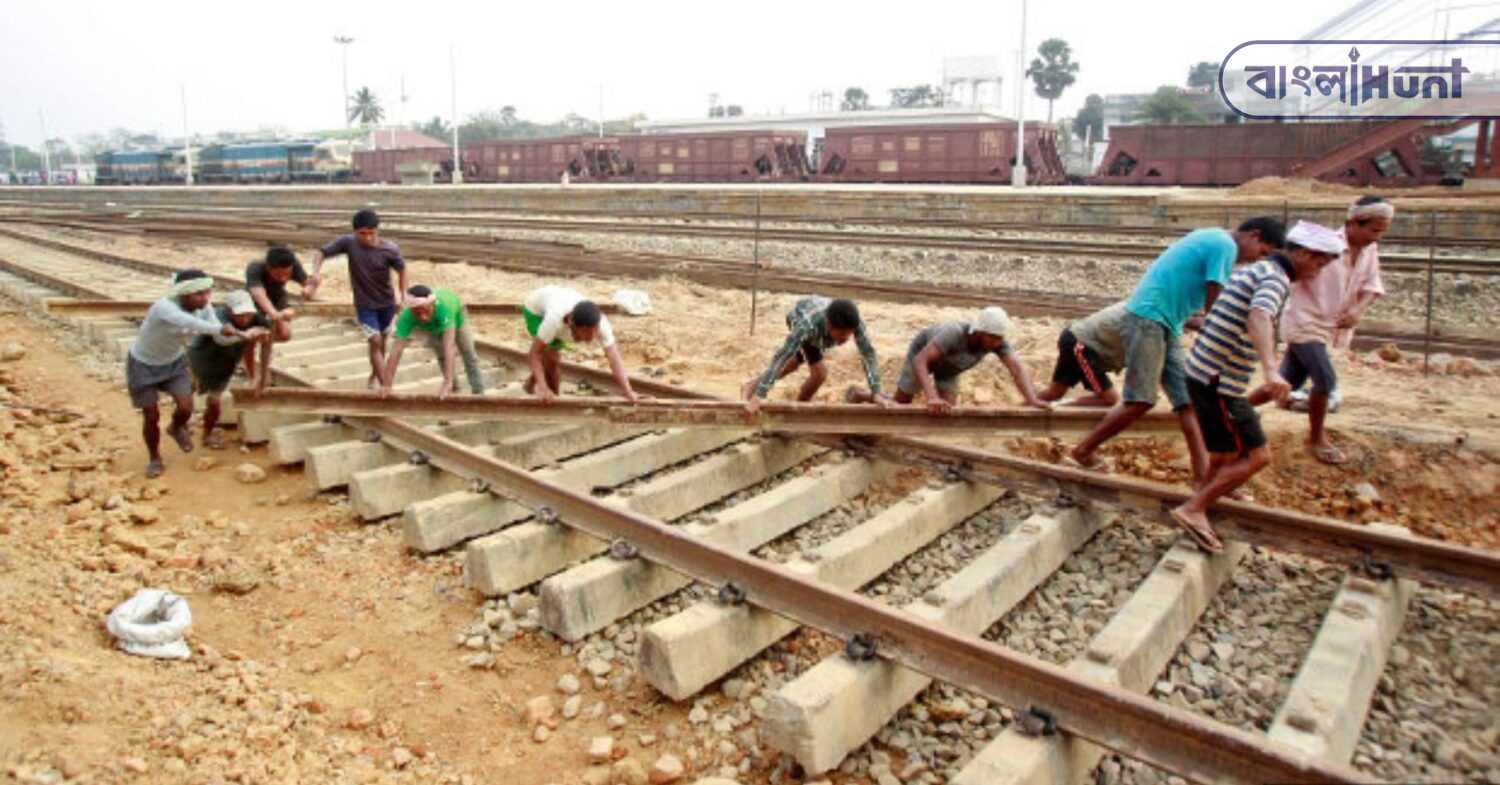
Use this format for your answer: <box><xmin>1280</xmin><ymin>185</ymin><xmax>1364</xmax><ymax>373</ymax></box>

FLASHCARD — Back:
<box><xmin>258</xmin><ymin>361</ymin><xmax>1361</xmax><ymax>785</ymax></box>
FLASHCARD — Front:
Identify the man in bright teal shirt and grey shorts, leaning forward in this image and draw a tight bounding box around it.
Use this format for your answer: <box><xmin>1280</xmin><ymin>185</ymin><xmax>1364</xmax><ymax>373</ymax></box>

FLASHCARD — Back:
<box><xmin>1070</xmin><ymin>218</ymin><xmax>1287</xmax><ymax>486</ymax></box>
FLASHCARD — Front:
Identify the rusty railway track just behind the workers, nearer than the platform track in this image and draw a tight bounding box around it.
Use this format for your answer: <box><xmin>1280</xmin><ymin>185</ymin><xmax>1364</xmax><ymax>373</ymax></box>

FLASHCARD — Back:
<box><xmin>0</xmin><ymin>221</ymin><xmax>1500</xmax><ymax>359</ymax></box>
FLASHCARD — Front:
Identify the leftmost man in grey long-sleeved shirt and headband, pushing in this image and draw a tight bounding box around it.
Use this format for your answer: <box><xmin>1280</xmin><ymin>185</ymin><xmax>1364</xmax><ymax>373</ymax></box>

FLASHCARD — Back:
<box><xmin>125</xmin><ymin>270</ymin><xmax>266</xmax><ymax>477</ymax></box>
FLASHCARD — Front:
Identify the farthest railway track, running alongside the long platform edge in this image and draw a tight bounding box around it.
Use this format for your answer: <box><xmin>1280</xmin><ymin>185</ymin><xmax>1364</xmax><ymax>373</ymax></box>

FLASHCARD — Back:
<box><xmin>2</xmin><ymin>209</ymin><xmax>1500</xmax><ymax>276</ymax></box>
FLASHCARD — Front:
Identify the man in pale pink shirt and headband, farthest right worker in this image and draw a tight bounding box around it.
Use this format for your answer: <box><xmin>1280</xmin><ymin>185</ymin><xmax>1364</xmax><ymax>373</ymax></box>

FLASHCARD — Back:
<box><xmin>1251</xmin><ymin>197</ymin><xmax>1397</xmax><ymax>464</ymax></box>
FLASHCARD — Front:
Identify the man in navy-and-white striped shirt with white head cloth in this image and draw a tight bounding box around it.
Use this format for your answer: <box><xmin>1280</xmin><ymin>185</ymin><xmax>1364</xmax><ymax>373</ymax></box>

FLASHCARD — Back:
<box><xmin>1172</xmin><ymin>221</ymin><xmax>1344</xmax><ymax>552</ymax></box>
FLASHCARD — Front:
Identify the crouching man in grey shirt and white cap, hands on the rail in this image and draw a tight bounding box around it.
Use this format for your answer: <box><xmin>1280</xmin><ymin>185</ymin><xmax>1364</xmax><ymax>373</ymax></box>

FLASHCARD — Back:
<box><xmin>848</xmin><ymin>306</ymin><xmax>1050</xmax><ymax>414</ymax></box>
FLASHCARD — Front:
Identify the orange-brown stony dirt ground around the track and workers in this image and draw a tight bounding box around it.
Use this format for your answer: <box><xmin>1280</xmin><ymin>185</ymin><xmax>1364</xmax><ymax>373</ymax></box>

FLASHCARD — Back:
<box><xmin>0</xmin><ymin>228</ymin><xmax>1500</xmax><ymax>785</ymax></box>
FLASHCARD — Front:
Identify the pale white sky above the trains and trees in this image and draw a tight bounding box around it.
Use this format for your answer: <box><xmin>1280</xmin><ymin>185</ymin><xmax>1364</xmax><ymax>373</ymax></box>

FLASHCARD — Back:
<box><xmin>0</xmin><ymin>0</ymin><xmax>1500</xmax><ymax>146</ymax></box>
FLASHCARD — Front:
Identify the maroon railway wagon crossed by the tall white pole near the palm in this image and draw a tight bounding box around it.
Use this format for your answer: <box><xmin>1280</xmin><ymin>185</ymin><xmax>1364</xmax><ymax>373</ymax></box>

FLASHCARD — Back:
<box><xmin>819</xmin><ymin>123</ymin><xmax>1067</xmax><ymax>185</ymax></box>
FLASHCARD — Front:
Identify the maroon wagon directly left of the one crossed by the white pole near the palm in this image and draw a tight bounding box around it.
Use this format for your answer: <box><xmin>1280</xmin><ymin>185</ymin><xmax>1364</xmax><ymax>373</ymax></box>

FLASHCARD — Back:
<box><xmin>618</xmin><ymin>131</ymin><xmax>810</xmax><ymax>183</ymax></box>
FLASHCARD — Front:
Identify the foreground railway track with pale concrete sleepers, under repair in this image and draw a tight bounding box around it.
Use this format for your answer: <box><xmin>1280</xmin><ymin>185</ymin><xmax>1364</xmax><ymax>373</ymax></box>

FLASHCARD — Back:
<box><xmin>0</xmin><ymin>240</ymin><xmax>1500</xmax><ymax>785</ymax></box>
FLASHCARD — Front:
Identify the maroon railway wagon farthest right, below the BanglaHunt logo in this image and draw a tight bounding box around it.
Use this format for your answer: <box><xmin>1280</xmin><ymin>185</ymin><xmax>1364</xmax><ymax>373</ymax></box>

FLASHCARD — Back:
<box><xmin>1089</xmin><ymin>120</ymin><xmax>1443</xmax><ymax>186</ymax></box>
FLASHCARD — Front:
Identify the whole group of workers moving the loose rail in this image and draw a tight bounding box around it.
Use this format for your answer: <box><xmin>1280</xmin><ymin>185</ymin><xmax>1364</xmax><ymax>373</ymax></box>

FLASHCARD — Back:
<box><xmin>126</xmin><ymin>197</ymin><xmax>1395</xmax><ymax>551</ymax></box>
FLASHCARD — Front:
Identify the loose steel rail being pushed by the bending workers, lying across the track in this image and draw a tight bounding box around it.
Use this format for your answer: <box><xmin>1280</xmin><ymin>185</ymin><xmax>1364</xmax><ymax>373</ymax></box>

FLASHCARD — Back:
<box><xmin>222</xmin><ymin>387</ymin><xmax>1179</xmax><ymax>437</ymax></box>
